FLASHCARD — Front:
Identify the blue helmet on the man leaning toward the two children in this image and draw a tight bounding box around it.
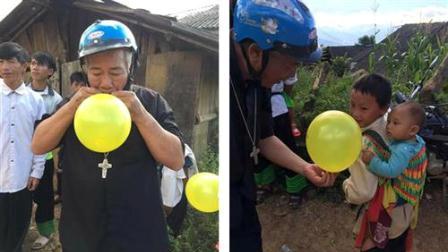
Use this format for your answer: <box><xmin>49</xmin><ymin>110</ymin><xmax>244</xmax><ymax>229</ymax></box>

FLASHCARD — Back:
<box><xmin>233</xmin><ymin>0</ymin><xmax>317</xmax><ymax>60</ymax></box>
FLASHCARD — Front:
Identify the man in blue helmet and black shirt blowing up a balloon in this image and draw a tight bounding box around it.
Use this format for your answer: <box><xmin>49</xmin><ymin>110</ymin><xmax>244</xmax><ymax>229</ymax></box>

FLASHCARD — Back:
<box><xmin>32</xmin><ymin>20</ymin><xmax>184</xmax><ymax>252</ymax></box>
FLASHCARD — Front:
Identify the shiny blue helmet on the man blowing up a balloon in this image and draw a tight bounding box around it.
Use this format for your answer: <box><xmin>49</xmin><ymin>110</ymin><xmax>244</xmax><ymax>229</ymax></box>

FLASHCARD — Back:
<box><xmin>78</xmin><ymin>20</ymin><xmax>138</xmax><ymax>59</ymax></box>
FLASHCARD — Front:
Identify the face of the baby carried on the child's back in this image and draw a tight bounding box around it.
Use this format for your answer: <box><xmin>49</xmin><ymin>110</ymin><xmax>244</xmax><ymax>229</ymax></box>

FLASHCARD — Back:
<box><xmin>386</xmin><ymin>106</ymin><xmax>420</xmax><ymax>140</ymax></box>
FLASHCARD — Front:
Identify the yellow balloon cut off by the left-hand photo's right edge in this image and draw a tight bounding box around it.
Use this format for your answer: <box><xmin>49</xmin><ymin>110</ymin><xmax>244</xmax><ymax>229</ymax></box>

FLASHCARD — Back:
<box><xmin>185</xmin><ymin>172</ymin><xmax>219</xmax><ymax>213</ymax></box>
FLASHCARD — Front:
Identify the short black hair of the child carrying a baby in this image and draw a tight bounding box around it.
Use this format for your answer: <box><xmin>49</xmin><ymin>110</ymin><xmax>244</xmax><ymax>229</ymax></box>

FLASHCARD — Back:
<box><xmin>353</xmin><ymin>73</ymin><xmax>392</xmax><ymax>108</ymax></box>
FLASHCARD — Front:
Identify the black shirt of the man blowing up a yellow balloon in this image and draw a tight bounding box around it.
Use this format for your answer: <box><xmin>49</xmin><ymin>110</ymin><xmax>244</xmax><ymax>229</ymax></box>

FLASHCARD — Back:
<box><xmin>59</xmin><ymin>86</ymin><xmax>183</xmax><ymax>252</ymax></box>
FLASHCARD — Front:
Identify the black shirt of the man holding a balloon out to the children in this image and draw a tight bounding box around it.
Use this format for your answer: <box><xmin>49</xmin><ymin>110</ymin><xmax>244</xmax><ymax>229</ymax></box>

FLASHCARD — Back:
<box><xmin>229</xmin><ymin>42</ymin><xmax>273</xmax><ymax>204</ymax></box>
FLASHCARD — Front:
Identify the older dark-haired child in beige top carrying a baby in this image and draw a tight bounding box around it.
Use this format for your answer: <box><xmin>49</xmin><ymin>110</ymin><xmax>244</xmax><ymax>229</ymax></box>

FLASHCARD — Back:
<box><xmin>343</xmin><ymin>74</ymin><xmax>413</xmax><ymax>251</ymax></box>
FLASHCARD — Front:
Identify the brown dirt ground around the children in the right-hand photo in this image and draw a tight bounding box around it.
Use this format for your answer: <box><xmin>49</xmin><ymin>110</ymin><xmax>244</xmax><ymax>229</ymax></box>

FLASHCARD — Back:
<box><xmin>258</xmin><ymin>177</ymin><xmax>448</xmax><ymax>252</ymax></box>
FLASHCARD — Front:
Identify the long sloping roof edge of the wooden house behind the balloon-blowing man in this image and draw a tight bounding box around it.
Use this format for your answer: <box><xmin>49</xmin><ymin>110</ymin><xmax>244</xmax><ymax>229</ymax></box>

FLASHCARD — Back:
<box><xmin>0</xmin><ymin>0</ymin><xmax>219</xmax><ymax>54</ymax></box>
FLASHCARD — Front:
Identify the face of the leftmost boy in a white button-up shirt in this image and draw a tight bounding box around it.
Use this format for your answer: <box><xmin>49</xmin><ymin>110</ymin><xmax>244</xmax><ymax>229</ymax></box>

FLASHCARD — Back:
<box><xmin>0</xmin><ymin>58</ymin><xmax>27</xmax><ymax>89</ymax></box>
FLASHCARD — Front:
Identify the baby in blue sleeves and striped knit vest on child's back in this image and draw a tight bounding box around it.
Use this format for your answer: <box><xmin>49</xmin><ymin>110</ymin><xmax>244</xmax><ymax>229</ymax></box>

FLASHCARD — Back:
<box><xmin>362</xmin><ymin>101</ymin><xmax>428</xmax><ymax>250</ymax></box>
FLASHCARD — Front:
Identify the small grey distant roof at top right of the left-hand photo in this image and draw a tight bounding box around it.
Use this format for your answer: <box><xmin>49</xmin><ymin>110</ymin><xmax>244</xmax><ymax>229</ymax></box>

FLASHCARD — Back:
<box><xmin>179</xmin><ymin>5</ymin><xmax>219</xmax><ymax>32</ymax></box>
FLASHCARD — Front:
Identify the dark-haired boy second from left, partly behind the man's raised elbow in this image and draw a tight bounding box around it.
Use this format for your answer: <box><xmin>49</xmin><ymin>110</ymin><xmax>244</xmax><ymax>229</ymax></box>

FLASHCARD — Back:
<box><xmin>27</xmin><ymin>52</ymin><xmax>62</xmax><ymax>250</ymax></box>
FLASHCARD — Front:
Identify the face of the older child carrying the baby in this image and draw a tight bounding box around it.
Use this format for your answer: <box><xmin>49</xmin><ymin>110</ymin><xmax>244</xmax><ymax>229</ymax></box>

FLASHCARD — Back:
<box><xmin>350</xmin><ymin>90</ymin><xmax>387</xmax><ymax>128</ymax></box>
